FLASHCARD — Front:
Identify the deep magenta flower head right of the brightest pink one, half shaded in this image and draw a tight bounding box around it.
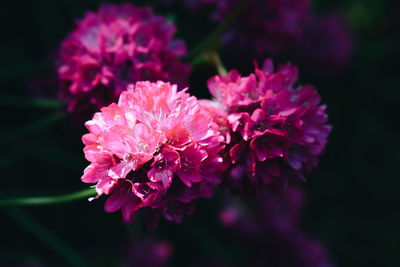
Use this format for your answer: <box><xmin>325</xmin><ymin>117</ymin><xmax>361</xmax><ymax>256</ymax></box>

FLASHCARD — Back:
<box><xmin>207</xmin><ymin>59</ymin><xmax>331</xmax><ymax>193</ymax></box>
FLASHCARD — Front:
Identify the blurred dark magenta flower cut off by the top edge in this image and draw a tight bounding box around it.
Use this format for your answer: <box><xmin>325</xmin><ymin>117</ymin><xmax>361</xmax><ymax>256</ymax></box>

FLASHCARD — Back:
<box><xmin>185</xmin><ymin>0</ymin><xmax>310</xmax><ymax>59</ymax></box>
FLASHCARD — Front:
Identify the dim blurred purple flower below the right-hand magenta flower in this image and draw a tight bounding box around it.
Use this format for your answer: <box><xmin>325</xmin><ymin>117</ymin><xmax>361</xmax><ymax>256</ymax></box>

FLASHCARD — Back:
<box><xmin>220</xmin><ymin>187</ymin><xmax>334</xmax><ymax>267</ymax></box>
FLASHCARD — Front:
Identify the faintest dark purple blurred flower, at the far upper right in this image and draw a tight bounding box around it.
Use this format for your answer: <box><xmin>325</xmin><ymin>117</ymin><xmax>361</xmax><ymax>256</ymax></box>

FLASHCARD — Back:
<box><xmin>297</xmin><ymin>13</ymin><xmax>354</xmax><ymax>76</ymax></box>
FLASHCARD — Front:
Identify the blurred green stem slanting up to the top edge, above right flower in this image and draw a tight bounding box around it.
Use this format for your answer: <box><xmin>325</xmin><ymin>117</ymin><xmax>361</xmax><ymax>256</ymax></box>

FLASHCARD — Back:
<box><xmin>187</xmin><ymin>0</ymin><xmax>248</xmax><ymax>62</ymax></box>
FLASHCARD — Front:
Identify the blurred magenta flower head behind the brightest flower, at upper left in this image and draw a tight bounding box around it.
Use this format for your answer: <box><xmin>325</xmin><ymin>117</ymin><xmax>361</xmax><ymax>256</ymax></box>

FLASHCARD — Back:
<box><xmin>57</xmin><ymin>4</ymin><xmax>190</xmax><ymax>112</ymax></box>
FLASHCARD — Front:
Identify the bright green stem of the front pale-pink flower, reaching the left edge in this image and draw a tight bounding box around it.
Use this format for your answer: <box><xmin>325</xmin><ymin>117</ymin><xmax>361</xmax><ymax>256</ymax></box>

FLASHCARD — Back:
<box><xmin>0</xmin><ymin>188</ymin><xmax>96</xmax><ymax>207</ymax></box>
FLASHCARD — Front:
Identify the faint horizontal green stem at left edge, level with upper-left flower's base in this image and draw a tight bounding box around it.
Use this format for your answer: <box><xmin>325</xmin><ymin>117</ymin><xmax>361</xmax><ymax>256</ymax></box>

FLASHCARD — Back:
<box><xmin>0</xmin><ymin>95</ymin><xmax>64</xmax><ymax>109</ymax></box>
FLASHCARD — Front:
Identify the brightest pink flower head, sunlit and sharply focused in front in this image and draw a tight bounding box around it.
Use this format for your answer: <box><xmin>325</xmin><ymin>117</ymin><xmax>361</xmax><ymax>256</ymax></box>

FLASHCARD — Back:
<box><xmin>82</xmin><ymin>81</ymin><xmax>223</xmax><ymax>224</ymax></box>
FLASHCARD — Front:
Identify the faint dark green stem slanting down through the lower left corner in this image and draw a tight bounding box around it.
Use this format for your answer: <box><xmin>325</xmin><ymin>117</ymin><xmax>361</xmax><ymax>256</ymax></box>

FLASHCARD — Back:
<box><xmin>6</xmin><ymin>208</ymin><xmax>85</xmax><ymax>266</ymax></box>
